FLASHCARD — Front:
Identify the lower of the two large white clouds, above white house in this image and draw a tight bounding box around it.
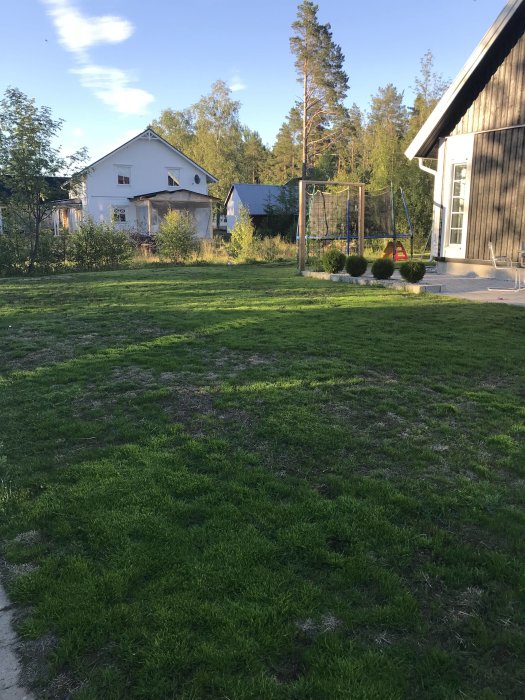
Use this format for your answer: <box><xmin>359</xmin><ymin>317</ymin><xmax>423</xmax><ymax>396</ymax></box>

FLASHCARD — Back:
<box><xmin>71</xmin><ymin>63</ymin><xmax>155</xmax><ymax>114</ymax></box>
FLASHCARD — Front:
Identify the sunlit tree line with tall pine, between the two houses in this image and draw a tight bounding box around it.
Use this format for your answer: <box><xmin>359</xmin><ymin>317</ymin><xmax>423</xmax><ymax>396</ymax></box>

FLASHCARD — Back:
<box><xmin>151</xmin><ymin>0</ymin><xmax>447</xmax><ymax>243</ymax></box>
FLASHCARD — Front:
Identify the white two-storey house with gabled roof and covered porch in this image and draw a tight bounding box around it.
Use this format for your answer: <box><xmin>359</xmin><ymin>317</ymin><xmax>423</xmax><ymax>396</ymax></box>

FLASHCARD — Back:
<box><xmin>53</xmin><ymin>129</ymin><xmax>217</xmax><ymax>238</ymax></box>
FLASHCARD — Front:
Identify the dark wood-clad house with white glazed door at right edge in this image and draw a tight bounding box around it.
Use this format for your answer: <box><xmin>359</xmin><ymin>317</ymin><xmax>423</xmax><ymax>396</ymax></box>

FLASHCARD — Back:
<box><xmin>405</xmin><ymin>0</ymin><xmax>525</xmax><ymax>276</ymax></box>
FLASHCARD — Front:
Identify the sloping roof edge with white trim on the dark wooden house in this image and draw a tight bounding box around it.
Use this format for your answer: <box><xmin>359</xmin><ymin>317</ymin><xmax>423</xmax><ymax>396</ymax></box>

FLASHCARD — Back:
<box><xmin>405</xmin><ymin>0</ymin><xmax>525</xmax><ymax>159</ymax></box>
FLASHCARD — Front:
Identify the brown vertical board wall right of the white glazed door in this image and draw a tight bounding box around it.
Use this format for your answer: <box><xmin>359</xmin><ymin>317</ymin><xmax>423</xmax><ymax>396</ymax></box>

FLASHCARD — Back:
<box><xmin>466</xmin><ymin>127</ymin><xmax>525</xmax><ymax>260</ymax></box>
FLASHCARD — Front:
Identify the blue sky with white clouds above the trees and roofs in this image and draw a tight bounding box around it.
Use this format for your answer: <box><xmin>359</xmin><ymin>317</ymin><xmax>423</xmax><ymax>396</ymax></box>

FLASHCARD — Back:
<box><xmin>0</xmin><ymin>0</ymin><xmax>505</xmax><ymax>162</ymax></box>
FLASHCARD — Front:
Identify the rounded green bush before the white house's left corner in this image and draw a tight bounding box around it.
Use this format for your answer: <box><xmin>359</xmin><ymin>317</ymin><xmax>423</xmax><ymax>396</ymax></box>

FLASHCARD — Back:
<box><xmin>69</xmin><ymin>219</ymin><xmax>133</xmax><ymax>270</ymax></box>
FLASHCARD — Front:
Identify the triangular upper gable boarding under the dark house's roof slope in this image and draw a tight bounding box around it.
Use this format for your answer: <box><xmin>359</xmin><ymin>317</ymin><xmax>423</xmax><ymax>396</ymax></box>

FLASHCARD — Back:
<box><xmin>450</xmin><ymin>26</ymin><xmax>525</xmax><ymax>136</ymax></box>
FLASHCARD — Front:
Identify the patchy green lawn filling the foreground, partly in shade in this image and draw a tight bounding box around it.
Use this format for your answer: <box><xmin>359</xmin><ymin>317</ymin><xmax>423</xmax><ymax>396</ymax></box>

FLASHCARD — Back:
<box><xmin>0</xmin><ymin>266</ymin><xmax>525</xmax><ymax>700</ymax></box>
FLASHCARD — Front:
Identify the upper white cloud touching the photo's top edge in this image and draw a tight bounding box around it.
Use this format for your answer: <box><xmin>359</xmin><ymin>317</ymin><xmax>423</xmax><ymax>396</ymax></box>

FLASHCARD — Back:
<box><xmin>43</xmin><ymin>0</ymin><xmax>134</xmax><ymax>55</ymax></box>
